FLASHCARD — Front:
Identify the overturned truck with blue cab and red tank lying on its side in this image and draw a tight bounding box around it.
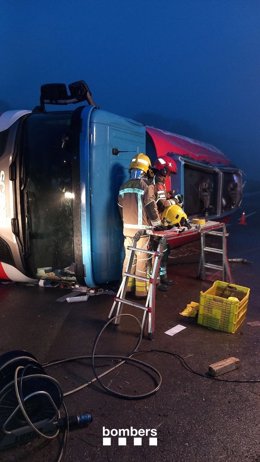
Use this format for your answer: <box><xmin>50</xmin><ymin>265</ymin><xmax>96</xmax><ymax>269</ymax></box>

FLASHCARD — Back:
<box><xmin>0</xmin><ymin>81</ymin><xmax>243</xmax><ymax>287</ymax></box>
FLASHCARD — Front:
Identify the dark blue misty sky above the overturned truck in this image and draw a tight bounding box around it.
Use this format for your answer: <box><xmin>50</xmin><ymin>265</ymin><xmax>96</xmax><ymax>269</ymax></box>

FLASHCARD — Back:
<box><xmin>0</xmin><ymin>0</ymin><xmax>260</xmax><ymax>180</ymax></box>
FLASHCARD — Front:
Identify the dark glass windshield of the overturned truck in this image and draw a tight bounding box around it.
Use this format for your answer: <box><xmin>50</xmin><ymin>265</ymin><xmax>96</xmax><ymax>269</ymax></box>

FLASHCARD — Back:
<box><xmin>21</xmin><ymin>112</ymin><xmax>78</xmax><ymax>274</ymax></box>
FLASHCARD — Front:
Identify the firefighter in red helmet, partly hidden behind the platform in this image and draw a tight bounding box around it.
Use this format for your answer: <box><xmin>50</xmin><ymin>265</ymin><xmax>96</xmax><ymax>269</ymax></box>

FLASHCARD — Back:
<box><xmin>153</xmin><ymin>156</ymin><xmax>177</xmax><ymax>291</ymax></box>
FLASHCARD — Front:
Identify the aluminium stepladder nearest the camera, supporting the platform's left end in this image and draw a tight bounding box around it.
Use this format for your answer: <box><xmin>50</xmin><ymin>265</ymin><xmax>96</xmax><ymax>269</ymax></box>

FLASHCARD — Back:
<box><xmin>108</xmin><ymin>233</ymin><xmax>164</xmax><ymax>339</ymax></box>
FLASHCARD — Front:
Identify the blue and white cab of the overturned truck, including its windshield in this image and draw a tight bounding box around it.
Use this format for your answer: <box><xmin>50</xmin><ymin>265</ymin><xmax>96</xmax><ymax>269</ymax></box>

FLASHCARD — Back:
<box><xmin>0</xmin><ymin>82</ymin><xmax>145</xmax><ymax>287</ymax></box>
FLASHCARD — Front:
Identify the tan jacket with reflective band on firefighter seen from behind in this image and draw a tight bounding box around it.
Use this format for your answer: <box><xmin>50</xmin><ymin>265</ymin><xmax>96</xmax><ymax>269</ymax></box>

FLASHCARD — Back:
<box><xmin>118</xmin><ymin>178</ymin><xmax>161</xmax><ymax>237</ymax></box>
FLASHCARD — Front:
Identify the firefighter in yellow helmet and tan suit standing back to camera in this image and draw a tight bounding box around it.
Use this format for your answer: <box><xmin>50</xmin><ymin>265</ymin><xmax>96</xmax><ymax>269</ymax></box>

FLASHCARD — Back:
<box><xmin>118</xmin><ymin>153</ymin><xmax>162</xmax><ymax>298</ymax></box>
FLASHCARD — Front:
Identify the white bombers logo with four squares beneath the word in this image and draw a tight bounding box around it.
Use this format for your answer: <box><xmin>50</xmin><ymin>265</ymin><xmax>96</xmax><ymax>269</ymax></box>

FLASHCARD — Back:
<box><xmin>102</xmin><ymin>427</ymin><xmax>157</xmax><ymax>446</ymax></box>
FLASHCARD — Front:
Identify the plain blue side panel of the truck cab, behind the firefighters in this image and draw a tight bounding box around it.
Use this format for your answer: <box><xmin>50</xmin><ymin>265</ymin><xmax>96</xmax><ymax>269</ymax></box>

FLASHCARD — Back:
<box><xmin>81</xmin><ymin>110</ymin><xmax>145</xmax><ymax>286</ymax></box>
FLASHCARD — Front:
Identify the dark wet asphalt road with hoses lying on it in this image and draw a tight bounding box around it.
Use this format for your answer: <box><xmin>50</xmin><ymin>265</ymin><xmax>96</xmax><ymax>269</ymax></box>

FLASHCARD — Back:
<box><xmin>0</xmin><ymin>195</ymin><xmax>260</xmax><ymax>462</ymax></box>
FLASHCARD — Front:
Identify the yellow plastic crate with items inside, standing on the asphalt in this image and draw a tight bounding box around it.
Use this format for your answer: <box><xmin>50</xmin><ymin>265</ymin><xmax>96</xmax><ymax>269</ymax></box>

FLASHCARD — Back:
<box><xmin>198</xmin><ymin>281</ymin><xmax>250</xmax><ymax>334</ymax></box>
